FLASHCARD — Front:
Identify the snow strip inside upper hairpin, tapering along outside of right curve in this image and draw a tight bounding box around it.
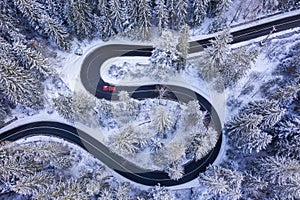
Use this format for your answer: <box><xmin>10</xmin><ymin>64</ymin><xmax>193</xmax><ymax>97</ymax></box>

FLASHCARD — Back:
<box><xmin>99</xmin><ymin>57</ymin><xmax>225</xmax><ymax>125</ymax></box>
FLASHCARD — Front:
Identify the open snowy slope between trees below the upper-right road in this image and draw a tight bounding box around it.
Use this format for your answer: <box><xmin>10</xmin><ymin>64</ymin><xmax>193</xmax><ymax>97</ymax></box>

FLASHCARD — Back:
<box><xmin>225</xmin><ymin>28</ymin><xmax>300</xmax><ymax>121</ymax></box>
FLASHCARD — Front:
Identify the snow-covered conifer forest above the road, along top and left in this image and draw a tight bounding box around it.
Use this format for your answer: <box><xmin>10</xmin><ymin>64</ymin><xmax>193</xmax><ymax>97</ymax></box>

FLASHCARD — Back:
<box><xmin>0</xmin><ymin>0</ymin><xmax>299</xmax><ymax>124</ymax></box>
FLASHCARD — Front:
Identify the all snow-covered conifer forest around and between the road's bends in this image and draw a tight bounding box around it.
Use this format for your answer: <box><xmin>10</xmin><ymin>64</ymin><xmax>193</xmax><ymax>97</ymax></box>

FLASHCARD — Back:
<box><xmin>0</xmin><ymin>0</ymin><xmax>300</xmax><ymax>200</ymax></box>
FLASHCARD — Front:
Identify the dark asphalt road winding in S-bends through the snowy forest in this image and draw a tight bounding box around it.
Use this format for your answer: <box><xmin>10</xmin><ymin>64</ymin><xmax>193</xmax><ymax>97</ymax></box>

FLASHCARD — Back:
<box><xmin>0</xmin><ymin>12</ymin><xmax>300</xmax><ymax>186</ymax></box>
